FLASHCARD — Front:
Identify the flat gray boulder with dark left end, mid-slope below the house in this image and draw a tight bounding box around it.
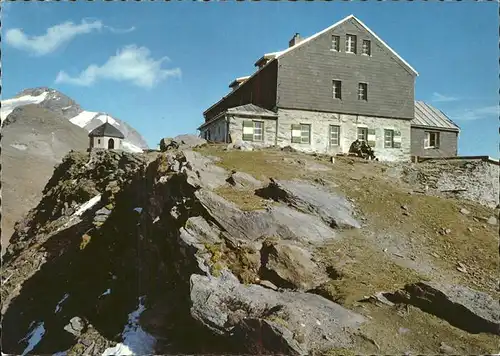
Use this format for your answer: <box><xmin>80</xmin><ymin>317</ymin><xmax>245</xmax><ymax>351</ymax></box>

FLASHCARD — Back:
<box><xmin>264</xmin><ymin>179</ymin><xmax>361</xmax><ymax>228</ymax></box>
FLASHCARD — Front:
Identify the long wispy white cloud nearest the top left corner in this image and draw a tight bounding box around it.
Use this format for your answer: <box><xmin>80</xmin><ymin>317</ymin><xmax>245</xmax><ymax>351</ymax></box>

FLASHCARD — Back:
<box><xmin>5</xmin><ymin>19</ymin><xmax>135</xmax><ymax>56</ymax></box>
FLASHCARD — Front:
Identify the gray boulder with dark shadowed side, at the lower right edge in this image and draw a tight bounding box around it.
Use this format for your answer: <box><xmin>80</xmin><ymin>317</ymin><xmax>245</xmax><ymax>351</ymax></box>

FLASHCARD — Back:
<box><xmin>385</xmin><ymin>282</ymin><xmax>500</xmax><ymax>335</ymax></box>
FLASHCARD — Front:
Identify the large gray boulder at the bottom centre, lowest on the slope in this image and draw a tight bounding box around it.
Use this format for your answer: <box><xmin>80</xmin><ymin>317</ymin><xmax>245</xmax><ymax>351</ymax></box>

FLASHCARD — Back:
<box><xmin>190</xmin><ymin>271</ymin><xmax>366</xmax><ymax>355</ymax></box>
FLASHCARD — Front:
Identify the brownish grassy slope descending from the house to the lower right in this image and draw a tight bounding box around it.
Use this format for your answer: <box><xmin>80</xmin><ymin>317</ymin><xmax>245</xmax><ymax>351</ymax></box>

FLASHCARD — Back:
<box><xmin>196</xmin><ymin>146</ymin><xmax>500</xmax><ymax>354</ymax></box>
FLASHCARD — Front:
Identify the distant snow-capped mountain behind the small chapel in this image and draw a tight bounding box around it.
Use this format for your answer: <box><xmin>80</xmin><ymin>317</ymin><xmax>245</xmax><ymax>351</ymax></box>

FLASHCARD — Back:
<box><xmin>1</xmin><ymin>87</ymin><xmax>147</xmax><ymax>254</ymax></box>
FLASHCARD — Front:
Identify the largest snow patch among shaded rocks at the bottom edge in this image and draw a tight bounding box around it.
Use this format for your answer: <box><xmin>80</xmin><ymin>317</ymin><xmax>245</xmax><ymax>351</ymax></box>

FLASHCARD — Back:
<box><xmin>102</xmin><ymin>297</ymin><xmax>156</xmax><ymax>356</ymax></box>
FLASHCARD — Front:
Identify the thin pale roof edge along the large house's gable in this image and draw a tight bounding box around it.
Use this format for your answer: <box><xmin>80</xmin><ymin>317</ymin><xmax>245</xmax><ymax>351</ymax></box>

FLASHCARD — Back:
<box><xmin>203</xmin><ymin>15</ymin><xmax>418</xmax><ymax>114</ymax></box>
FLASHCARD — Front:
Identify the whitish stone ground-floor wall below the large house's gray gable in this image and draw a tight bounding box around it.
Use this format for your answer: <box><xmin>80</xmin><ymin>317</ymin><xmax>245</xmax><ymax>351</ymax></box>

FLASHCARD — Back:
<box><xmin>277</xmin><ymin>109</ymin><xmax>411</xmax><ymax>161</ymax></box>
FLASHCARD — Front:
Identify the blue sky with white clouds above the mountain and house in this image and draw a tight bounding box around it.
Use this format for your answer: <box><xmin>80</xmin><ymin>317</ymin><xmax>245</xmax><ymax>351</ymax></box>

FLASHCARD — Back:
<box><xmin>2</xmin><ymin>1</ymin><xmax>499</xmax><ymax>157</ymax></box>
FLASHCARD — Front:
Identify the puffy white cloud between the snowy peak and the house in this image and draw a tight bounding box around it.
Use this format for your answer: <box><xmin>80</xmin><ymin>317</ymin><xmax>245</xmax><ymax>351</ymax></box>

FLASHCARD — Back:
<box><xmin>56</xmin><ymin>45</ymin><xmax>181</xmax><ymax>88</ymax></box>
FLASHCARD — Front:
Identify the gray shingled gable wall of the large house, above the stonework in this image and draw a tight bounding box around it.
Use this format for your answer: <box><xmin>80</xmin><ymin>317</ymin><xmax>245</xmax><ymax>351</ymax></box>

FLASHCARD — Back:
<box><xmin>276</xmin><ymin>18</ymin><xmax>416</xmax><ymax>120</ymax></box>
